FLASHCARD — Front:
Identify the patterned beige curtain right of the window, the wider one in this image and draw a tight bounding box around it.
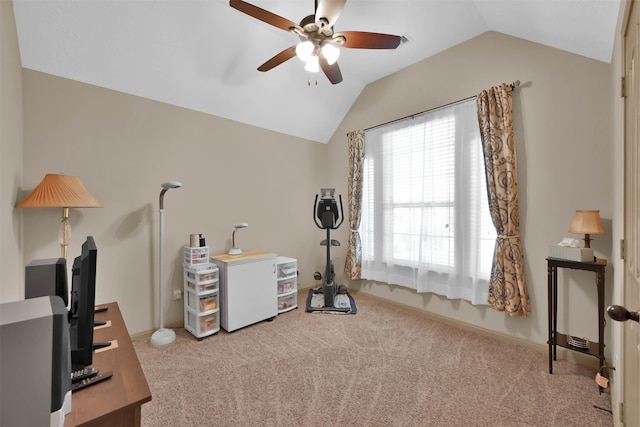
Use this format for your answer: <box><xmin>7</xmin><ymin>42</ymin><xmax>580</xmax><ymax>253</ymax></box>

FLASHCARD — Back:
<box><xmin>476</xmin><ymin>84</ymin><xmax>531</xmax><ymax>316</ymax></box>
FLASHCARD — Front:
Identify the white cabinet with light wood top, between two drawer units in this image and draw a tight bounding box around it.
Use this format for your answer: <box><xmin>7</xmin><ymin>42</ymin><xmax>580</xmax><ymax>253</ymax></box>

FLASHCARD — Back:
<box><xmin>211</xmin><ymin>251</ymin><xmax>278</xmax><ymax>332</ymax></box>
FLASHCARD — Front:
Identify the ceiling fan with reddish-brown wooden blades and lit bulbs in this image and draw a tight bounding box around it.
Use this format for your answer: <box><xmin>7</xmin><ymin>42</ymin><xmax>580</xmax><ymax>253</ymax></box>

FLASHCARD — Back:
<box><xmin>229</xmin><ymin>0</ymin><xmax>402</xmax><ymax>84</ymax></box>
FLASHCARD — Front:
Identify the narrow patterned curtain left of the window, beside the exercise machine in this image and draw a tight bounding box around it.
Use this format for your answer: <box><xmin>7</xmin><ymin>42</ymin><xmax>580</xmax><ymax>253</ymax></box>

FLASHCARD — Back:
<box><xmin>344</xmin><ymin>130</ymin><xmax>364</xmax><ymax>280</ymax></box>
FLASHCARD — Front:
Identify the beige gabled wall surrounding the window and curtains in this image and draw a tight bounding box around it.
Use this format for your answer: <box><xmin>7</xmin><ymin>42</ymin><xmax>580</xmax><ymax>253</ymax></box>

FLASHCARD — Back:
<box><xmin>329</xmin><ymin>32</ymin><xmax>619</xmax><ymax>362</ymax></box>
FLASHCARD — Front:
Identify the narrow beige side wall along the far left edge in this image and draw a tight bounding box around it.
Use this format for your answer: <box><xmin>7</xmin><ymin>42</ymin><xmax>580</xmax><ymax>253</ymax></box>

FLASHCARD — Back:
<box><xmin>0</xmin><ymin>1</ymin><xmax>24</xmax><ymax>302</ymax></box>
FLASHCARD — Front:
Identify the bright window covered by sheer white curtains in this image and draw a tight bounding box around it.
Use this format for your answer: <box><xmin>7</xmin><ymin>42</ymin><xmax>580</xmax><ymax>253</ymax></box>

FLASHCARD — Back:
<box><xmin>360</xmin><ymin>99</ymin><xmax>496</xmax><ymax>304</ymax></box>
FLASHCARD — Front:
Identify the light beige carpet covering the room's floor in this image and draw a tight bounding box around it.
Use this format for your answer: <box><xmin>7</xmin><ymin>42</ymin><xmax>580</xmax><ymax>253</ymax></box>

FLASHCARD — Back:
<box><xmin>134</xmin><ymin>291</ymin><xmax>613</xmax><ymax>426</ymax></box>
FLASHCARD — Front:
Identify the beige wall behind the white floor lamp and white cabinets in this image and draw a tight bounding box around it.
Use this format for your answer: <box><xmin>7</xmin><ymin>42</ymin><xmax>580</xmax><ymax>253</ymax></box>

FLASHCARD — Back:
<box><xmin>23</xmin><ymin>70</ymin><xmax>326</xmax><ymax>333</ymax></box>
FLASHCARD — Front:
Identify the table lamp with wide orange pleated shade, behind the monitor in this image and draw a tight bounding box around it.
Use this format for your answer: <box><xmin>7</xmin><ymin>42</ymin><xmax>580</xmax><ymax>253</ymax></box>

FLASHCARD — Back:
<box><xmin>16</xmin><ymin>173</ymin><xmax>103</xmax><ymax>258</ymax></box>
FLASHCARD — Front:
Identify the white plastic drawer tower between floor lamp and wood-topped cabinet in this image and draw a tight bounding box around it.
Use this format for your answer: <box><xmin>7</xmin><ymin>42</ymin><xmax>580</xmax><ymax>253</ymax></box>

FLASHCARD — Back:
<box><xmin>184</xmin><ymin>260</ymin><xmax>220</xmax><ymax>339</ymax></box>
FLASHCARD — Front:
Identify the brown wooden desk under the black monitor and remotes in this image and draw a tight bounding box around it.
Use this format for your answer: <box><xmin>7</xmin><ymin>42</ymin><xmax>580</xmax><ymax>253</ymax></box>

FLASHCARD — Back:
<box><xmin>64</xmin><ymin>302</ymin><xmax>151</xmax><ymax>427</ymax></box>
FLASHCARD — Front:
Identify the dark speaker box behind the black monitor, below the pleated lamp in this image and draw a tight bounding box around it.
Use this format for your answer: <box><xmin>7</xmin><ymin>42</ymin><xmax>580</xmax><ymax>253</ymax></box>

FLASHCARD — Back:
<box><xmin>24</xmin><ymin>258</ymin><xmax>69</xmax><ymax>307</ymax></box>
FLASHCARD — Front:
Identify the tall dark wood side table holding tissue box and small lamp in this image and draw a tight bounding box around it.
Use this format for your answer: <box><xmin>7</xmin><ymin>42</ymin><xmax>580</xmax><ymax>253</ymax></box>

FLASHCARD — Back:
<box><xmin>547</xmin><ymin>258</ymin><xmax>607</xmax><ymax>374</ymax></box>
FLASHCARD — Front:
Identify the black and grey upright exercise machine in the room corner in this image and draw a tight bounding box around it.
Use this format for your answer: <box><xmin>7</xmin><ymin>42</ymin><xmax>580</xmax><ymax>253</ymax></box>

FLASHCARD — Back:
<box><xmin>312</xmin><ymin>188</ymin><xmax>350</xmax><ymax>311</ymax></box>
